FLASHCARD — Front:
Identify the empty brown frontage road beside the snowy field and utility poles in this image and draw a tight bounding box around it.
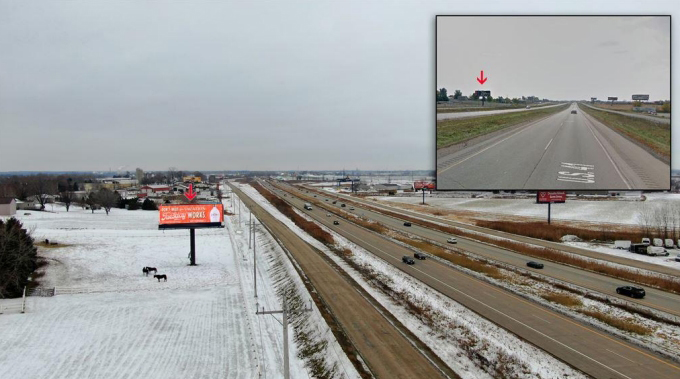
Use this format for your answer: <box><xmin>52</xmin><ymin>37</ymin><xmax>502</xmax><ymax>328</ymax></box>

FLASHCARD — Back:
<box><xmin>231</xmin><ymin>186</ymin><xmax>455</xmax><ymax>379</ymax></box>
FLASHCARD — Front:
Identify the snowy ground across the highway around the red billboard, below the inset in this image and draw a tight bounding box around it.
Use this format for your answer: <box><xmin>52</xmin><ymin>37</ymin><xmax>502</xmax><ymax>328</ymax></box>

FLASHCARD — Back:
<box><xmin>378</xmin><ymin>193</ymin><xmax>680</xmax><ymax>225</ymax></box>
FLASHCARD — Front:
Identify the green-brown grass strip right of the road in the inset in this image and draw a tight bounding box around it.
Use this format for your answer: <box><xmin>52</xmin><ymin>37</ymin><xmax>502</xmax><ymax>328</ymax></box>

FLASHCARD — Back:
<box><xmin>579</xmin><ymin>105</ymin><xmax>671</xmax><ymax>162</ymax></box>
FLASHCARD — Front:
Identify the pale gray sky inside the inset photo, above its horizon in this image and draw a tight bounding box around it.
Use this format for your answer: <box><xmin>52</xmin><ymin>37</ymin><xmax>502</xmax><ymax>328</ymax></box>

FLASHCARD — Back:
<box><xmin>437</xmin><ymin>17</ymin><xmax>671</xmax><ymax>100</ymax></box>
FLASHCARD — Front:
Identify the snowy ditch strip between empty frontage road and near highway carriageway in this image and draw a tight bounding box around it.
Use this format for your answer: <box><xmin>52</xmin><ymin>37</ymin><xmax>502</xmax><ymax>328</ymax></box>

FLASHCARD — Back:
<box><xmin>239</xmin><ymin>185</ymin><xmax>585</xmax><ymax>379</ymax></box>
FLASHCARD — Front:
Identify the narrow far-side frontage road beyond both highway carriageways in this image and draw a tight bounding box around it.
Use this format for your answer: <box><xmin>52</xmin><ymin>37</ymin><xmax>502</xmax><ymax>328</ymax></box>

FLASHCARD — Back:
<box><xmin>318</xmin><ymin>187</ymin><xmax>680</xmax><ymax>277</ymax></box>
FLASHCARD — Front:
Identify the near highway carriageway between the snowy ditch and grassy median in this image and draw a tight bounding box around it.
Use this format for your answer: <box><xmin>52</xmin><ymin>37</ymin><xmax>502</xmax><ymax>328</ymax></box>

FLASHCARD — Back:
<box><xmin>258</xmin><ymin>180</ymin><xmax>680</xmax><ymax>379</ymax></box>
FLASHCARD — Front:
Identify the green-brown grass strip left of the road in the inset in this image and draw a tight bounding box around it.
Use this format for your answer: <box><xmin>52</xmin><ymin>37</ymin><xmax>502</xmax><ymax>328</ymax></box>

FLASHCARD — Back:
<box><xmin>437</xmin><ymin>104</ymin><xmax>569</xmax><ymax>149</ymax></box>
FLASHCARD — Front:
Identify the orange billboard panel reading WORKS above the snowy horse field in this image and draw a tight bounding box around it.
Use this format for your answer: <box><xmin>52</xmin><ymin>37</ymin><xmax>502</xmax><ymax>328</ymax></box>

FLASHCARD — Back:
<box><xmin>158</xmin><ymin>204</ymin><xmax>224</xmax><ymax>229</ymax></box>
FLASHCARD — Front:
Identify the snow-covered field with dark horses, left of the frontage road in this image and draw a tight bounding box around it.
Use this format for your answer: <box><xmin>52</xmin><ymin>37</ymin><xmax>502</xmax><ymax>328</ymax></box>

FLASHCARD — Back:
<box><xmin>0</xmin><ymin>205</ymin><xmax>356</xmax><ymax>379</ymax></box>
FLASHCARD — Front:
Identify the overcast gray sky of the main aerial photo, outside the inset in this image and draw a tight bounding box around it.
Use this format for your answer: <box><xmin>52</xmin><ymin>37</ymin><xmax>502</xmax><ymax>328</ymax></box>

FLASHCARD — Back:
<box><xmin>0</xmin><ymin>0</ymin><xmax>680</xmax><ymax>171</ymax></box>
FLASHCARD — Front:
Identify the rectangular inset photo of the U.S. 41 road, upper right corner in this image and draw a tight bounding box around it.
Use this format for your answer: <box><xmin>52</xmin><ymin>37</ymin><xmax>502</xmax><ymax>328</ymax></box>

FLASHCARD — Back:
<box><xmin>436</xmin><ymin>16</ymin><xmax>671</xmax><ymax>191</ymax></box>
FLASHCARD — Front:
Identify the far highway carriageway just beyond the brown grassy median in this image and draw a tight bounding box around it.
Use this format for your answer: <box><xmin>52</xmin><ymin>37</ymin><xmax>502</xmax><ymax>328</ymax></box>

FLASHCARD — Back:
<box><xmin>278</xmin><ymin>183</ymin><xmax>680</xmax><ymax>316</ymax></box>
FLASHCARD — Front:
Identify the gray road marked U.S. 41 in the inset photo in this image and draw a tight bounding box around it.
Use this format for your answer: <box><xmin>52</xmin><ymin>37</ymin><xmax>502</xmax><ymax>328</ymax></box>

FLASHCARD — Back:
<box><xmin>437</xmin><ymin>103</ymin><xmax>670</xmax><ymax>190</ymax></box>
